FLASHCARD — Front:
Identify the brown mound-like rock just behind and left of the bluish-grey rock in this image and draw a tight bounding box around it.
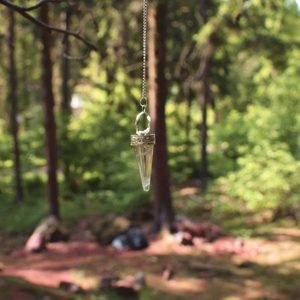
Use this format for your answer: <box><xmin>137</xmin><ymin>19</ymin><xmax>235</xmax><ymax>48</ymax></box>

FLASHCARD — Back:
<box><xmin>91</xmin><ymin>216</ymin><xmax>131</xmax><ymax>245</ymax></box>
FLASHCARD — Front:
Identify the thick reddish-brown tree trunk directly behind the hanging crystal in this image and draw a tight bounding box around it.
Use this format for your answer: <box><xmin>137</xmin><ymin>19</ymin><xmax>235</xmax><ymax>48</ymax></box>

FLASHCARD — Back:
<box><xmin>149</xmin><ymin>2</ymin><xmax>174</xmax><ymax>232</ymax></box>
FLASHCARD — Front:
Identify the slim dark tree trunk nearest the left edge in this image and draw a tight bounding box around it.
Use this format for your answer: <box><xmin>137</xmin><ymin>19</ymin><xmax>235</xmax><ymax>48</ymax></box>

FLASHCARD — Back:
<box><xmin>8</xmin><ymin>9</ymin><xmax>24</xmax><ymax>202</ymax></box>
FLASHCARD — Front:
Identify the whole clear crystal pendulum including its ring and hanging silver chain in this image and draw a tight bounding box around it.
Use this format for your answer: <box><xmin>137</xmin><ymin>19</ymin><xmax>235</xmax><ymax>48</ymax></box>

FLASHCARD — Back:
<box><xmin>131</xmin><ymin>0</ymin><xmax>155</xmax><ymax>192</ymax></box>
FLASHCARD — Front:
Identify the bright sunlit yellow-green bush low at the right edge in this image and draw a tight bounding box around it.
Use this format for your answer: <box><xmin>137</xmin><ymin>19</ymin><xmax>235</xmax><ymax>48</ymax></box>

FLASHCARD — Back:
<box><xmin>219</xmin><ymin>144</ymin><xmax>300</xmax><ymax>212</ymax></box>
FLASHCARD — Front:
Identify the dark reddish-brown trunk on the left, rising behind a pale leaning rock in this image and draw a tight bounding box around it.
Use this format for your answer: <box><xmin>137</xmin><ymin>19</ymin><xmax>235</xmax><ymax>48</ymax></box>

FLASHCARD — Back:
<box><xmin>40</xmin><ymin>5</ymin><xmax>59</xmax><ymax>218</ymax></box>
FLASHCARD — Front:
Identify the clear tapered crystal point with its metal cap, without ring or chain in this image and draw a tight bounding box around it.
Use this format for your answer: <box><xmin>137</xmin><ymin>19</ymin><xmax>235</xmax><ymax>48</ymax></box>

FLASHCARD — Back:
<box><xmin>131</xmin><ymin>134</ymin><xmax>155</xmax><ymax>192</ymax></box>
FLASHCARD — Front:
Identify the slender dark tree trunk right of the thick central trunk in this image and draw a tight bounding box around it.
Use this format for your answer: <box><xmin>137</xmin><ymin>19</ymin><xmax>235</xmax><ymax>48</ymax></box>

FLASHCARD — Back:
<box><xmin>200</xmin><ymin>0</ymin><xmax>212</xmax><ymax>190</ymax></box>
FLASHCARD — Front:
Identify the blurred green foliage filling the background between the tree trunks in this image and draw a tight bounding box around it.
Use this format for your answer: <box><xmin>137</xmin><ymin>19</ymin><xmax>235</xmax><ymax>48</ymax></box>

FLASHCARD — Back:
<box><xmin>0</xmin><ymin>0</ymin><xmax>300</xmax><ymax>237</ymax></box>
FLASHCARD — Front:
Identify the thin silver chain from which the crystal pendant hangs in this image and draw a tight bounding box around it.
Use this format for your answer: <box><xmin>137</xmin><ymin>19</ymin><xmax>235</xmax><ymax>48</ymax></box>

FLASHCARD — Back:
<box><xmin>140</xmin><ymin>0</ymin><xmax>148</xmax><ymax>112</ymax></box>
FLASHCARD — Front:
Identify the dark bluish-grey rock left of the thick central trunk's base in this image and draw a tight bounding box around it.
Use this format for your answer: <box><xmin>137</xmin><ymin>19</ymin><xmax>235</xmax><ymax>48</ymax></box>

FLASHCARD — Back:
<box><xmin>112</xmin><ymin>227</ymin><xmax>149</xmax><ymax>251</ymax></box>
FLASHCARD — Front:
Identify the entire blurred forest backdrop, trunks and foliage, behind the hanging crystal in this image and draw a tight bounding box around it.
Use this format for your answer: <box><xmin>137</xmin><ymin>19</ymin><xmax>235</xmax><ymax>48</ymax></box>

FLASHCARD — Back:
<box><xmin>0</xmin><ymin>0</ymin><xmax>300</xmax><ymax>239</ymax></box>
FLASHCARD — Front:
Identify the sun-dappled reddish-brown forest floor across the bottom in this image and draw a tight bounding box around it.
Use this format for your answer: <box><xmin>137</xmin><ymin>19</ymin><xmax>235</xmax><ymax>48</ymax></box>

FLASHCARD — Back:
<box><xmin>0</xmin><ymin>220</ymin><xmax>300</xmax><ymax>300</ymax></box>
